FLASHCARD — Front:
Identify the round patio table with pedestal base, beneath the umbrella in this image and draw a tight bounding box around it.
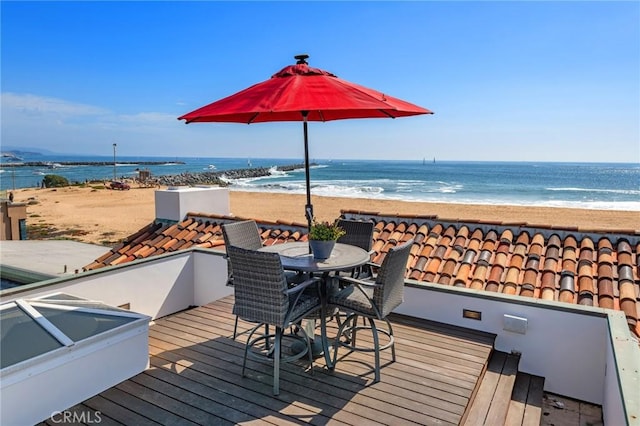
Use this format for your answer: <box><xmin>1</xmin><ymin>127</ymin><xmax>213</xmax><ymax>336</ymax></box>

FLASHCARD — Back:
<box><xmin>259</xmin><ymin>242</ymin><xmax>371</xmax><ymax>368</ymax></box>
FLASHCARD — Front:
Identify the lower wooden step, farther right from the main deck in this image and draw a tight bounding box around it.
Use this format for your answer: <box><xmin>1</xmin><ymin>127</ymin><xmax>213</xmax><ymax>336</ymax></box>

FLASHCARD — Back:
<box><xmin>504</xmin><ymin>373</ymin><xmax>544</xmax><ymax>426</ymax></box>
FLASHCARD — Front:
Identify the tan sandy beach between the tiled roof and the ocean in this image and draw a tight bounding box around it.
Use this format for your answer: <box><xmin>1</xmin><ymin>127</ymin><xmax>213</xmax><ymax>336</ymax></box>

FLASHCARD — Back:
<box><xmin>14</xmin><ymin>187</ymin><xmax>640</xmax><ymax>245</ymax></box>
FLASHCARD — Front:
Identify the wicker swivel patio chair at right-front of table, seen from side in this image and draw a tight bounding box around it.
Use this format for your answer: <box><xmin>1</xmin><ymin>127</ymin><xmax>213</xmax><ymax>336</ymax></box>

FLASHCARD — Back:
<box><xmin>328</xmin><ymin>240</ymin><xmax>413</xmax><ymax>383</ymax></box>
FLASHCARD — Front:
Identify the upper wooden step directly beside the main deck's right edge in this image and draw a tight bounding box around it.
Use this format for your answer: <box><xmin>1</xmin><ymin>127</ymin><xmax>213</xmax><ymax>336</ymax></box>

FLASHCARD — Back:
<box><xmin>463</xmin><ymin>351</ymin><xmax>520</xmax><ymax>426</ymax></box>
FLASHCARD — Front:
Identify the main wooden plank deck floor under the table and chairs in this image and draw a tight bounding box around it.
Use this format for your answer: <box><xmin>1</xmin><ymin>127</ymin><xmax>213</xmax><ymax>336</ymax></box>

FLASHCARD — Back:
<box><xmin>46</xmin><ymin>296</ymin><xmax>494</xmax><ymax>425</ymax></box>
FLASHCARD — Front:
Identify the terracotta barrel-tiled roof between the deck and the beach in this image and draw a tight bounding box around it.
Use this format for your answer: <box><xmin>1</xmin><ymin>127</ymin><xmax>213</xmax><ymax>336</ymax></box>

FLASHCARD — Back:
<box><xmin>84</xmin><ymin>211</ymin><xmax>640</xmax><ymax>336</ymax></box>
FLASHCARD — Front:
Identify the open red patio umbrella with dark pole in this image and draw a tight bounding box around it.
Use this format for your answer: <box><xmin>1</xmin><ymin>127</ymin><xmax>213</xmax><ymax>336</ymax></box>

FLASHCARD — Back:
<box><xmin>178</xmin><ymin>55</ymin><xmax>433</xmax><ymax>230</ymax></box>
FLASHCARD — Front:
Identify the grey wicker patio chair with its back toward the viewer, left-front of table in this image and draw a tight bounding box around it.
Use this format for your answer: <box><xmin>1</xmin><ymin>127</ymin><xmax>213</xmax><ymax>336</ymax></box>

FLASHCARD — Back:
<box><xmin>227</xmin><ymin>246</ymin><xmax>321</xmax><ymax>395</ymax></box>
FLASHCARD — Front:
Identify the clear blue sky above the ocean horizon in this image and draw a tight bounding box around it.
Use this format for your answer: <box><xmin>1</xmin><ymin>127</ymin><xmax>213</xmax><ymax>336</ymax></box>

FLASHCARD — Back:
<box><xmin>0</xmin><ymin>1</ymin><xmax>640</xmax><ymax>162</ymax></box>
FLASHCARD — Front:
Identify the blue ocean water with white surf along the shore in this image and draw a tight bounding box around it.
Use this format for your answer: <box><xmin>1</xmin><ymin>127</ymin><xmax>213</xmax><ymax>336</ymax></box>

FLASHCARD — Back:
<box><xmin>0</xmin><ymin>155</ymin><xmax>640</xmax><ymax>211</ymax></box>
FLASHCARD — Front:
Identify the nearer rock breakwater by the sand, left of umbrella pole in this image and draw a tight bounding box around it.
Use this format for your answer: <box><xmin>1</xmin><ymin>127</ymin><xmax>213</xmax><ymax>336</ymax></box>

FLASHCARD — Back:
<box><xmin>153</xmin><ymin>164</ymin><xmax>304</xmax><ymax>186</ymax></box>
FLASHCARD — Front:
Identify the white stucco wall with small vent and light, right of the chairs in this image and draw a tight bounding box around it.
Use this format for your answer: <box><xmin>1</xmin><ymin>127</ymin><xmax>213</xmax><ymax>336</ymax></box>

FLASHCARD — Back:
<box><xmin>396</xmin><ymin>284</ymin><xmax>620</xmax><ymax>404</ymax></box>
